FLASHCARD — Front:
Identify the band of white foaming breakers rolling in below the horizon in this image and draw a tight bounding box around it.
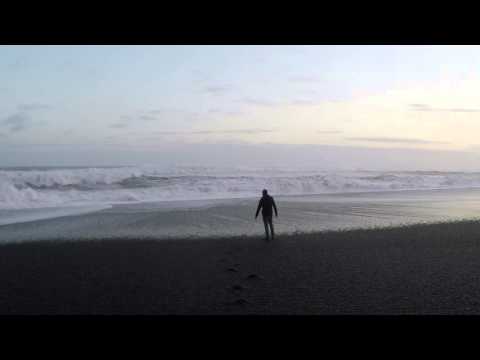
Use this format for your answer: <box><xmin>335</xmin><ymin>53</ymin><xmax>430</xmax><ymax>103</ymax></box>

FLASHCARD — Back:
<box><xmin>0</xmin><ymin>167</ymin><xmax>480</xmax><ymax>209</ymax></box>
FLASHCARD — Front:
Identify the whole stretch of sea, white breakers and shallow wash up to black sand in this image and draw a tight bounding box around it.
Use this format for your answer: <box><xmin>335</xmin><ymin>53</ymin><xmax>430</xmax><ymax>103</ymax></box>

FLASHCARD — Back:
<box><xmin>0</xmin><ymin>166</ymin><xmax>480</xmax><ymax>241</ymax></box>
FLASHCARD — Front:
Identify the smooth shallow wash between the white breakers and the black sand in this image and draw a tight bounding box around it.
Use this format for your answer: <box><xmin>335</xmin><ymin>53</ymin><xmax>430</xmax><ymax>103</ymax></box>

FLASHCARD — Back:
<box><xmin>0</xmin><ymin>189</ymin><xmax>480</xmax><ymax>242</ymax></box>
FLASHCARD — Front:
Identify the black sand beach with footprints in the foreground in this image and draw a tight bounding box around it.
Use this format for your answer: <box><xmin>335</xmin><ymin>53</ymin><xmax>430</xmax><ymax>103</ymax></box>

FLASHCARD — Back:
<box><xmin>0</xmin><ymin>221</ymin><xmax>480</xmax><ymax>314</ymax></box>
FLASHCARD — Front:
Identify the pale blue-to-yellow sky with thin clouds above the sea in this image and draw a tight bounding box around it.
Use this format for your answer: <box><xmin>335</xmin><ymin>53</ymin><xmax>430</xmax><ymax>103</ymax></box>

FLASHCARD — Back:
<box><xmin>0</xmin><ymin>46</ymin><xmax>480</xmax><ymax>165</ymax></box>
